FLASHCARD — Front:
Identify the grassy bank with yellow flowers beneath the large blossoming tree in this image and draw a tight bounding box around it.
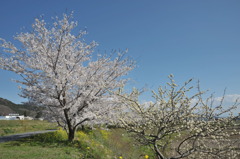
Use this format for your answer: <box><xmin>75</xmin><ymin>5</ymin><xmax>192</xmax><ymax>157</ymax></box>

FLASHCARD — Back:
<box><xmin>0</xmin><ymin>129</ymin><xmax>155</xmax><ymax>159</ymax></box>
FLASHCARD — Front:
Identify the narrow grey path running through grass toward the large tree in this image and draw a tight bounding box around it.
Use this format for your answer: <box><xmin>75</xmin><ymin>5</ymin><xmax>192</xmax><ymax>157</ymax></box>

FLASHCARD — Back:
<box><xmin>0</xmin><ymin>130</ymin><xmax>56</xmax><ymax>143</ymax></box>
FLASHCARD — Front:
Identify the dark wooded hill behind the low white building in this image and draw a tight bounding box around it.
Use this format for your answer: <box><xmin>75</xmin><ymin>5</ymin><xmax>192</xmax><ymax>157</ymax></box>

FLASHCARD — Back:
<box><xmin>0</xmin><ymin>98</ymin><xmax>43</xmax><ymax>117</ymax></box>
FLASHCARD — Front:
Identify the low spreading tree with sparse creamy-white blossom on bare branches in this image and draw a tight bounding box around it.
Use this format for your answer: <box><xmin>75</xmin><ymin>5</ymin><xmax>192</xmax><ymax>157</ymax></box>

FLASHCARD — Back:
<box><xmin>119</xmin><ymin>75</ymin><xmax>240</xmax><ymax>159</ymax></box>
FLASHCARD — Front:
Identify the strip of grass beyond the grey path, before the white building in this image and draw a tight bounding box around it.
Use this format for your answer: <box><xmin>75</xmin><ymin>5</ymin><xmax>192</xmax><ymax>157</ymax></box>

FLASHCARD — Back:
<box><xmin>0</xmin><ymin>120</ymin><xmax>57</xmax><ymax>136</ymax></box>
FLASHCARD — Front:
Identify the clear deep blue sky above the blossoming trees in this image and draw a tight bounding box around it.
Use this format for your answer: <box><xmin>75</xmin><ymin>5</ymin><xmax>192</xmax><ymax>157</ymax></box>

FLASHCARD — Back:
<box><xmin>0</xmin><ymin>0</ymin><xmax>240</xmax><ymax>103</ymax></box>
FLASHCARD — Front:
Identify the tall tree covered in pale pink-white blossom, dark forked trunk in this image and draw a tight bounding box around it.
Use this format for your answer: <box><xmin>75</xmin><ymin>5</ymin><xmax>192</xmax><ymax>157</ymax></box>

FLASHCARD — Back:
<box><xmin>0</xmin><ymin>14</ymin><xmax>134</xmax><ymax>141</ymax></box>
